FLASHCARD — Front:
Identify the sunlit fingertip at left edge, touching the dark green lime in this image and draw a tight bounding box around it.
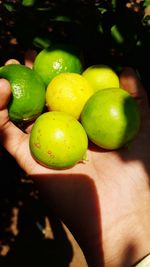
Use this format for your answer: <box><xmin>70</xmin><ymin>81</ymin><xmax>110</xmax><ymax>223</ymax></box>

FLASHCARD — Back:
<box><xmin>0</xmin><ymin>79</ymin><xmax>11</xmax><ymax>111</ymax></box>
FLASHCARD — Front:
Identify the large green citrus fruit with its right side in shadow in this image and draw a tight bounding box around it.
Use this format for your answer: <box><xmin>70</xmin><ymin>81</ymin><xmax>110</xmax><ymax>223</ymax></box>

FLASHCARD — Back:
<box><xmin>81</xmin><ymin>88</ymin><xmax>140</xmax><ymax>149</ymax></box>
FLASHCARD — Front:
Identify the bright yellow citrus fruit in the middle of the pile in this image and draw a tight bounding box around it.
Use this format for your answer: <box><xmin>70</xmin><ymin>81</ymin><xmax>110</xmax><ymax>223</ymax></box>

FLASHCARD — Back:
<box><xmin>46</xmin><ymin>73</ymin><xmax>93</xmax><ymax>119</ymax></box>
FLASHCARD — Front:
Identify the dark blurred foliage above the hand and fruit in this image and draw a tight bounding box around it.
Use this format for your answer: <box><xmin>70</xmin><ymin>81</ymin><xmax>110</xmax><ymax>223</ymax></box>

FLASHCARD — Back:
<box><xmin>0</xmin><ymin>0</ymin><xmax>150</xmax><ymax>67</ymax></box>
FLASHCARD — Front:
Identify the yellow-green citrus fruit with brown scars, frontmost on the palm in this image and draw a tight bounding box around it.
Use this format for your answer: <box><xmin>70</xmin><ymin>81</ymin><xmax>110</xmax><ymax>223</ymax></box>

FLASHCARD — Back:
<box><xmin>29</xmin><ymin>111</ymin><xmax>88</xmax><ymax>169</ymax></box>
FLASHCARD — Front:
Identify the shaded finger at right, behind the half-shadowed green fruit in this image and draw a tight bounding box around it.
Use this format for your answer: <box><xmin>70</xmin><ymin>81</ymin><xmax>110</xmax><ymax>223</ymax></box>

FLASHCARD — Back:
<box><xmin>120</xmin><ymin>67</ymin><xmax>150</xmax><ymax>119</ymax></box>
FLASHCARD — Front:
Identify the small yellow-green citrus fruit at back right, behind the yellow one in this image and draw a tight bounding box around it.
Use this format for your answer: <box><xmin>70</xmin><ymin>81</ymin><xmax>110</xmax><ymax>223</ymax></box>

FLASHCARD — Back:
<box><xmin>82</xmin><ymin>64</ymin><xmax>119</xmax><ymax>92</ymax></box>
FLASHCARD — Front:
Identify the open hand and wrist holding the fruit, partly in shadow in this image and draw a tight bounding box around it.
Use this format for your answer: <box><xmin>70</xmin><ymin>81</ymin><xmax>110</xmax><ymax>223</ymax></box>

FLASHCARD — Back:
<box><xmin>0</xmin><ymin>57</ymin><xmax>150</xmax><ymax>267</ymax></box>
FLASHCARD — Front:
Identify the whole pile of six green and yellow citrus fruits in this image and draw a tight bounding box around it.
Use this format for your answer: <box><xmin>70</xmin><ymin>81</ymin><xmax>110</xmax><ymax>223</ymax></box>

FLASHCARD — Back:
<box><xmin>0</xmin><ymin>44</ymin><xmax>140</xmax><ymax>169</ymax></box>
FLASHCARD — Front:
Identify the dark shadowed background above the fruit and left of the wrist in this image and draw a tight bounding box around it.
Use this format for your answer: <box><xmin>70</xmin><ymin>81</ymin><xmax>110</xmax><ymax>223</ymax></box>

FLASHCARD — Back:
<box><xmin>0</xmin><ymin>0</ymin><xmax>150</xmax><ymax>267</ymax></box>
